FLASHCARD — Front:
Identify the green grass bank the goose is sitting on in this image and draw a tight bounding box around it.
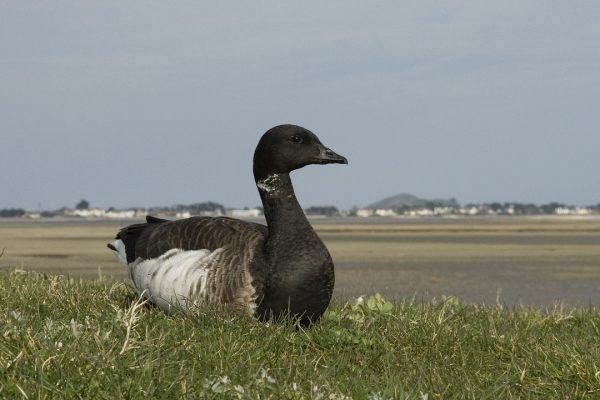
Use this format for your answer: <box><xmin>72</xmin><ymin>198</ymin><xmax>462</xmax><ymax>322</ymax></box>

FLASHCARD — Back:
<box><xmin>0</xmin><ymin>271</ymin><xmax>600</xmax><ymax>399</ymax></box>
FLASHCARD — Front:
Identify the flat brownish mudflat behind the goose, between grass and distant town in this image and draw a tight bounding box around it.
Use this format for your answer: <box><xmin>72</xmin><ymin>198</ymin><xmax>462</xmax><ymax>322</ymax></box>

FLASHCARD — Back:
<box><xmin>0</xmin><ymin>217</ymin><xmax>600</xmax><ymax>307</ymax></box>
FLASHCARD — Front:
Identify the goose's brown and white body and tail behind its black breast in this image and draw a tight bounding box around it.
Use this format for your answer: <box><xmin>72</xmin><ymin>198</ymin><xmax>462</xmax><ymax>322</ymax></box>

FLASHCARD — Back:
<box><xmin>109</xmin><ymin>217</ymin><xmax>268</xmax><ymax>312</ymax></box>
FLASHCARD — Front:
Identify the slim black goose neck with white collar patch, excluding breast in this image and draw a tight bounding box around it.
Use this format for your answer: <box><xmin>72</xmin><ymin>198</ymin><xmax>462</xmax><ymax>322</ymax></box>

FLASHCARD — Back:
<box><xmin>256</xmin><ymin>173</ymin><xmax>312</xmax><ymax>238</ymax></box>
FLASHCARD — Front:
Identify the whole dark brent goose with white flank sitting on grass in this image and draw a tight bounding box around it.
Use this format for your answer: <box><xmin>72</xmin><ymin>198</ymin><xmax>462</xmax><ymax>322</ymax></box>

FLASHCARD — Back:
<box><xmin>108</xmin><ymin>125</ymin><xmax>348</xmax><ymax>325</ymax></box>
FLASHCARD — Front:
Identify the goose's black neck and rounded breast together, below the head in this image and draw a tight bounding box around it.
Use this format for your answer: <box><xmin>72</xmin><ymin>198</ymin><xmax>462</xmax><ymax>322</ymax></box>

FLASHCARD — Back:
<box><xmin>255</xmin><ymin>169</ymin><xmax>335</xmax><ymax>325</ymax></box>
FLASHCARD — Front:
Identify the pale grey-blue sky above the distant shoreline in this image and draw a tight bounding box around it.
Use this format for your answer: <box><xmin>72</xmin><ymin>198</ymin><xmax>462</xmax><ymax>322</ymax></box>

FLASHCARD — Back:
<box><xmin>0</xmin><ymin>0</ymin><xmax>600</xmax><ymax>211</ymax></box>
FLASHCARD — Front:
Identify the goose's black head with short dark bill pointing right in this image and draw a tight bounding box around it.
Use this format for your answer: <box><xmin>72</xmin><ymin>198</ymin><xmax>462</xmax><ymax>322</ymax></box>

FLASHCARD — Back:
<box><xmin>254</xmin><ymin>125</ymin><xmax>348</xmax><ymax>179</ymax></box>
